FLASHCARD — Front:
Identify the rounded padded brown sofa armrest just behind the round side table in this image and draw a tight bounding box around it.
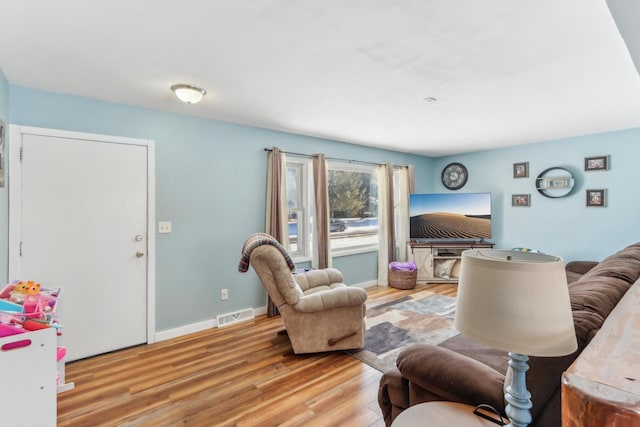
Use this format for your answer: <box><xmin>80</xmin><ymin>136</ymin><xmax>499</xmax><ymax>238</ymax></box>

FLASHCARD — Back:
<box><xmin>396</xmin><ymin>345</ymin><xmax>505</xmax><ymax>414</ymax></box>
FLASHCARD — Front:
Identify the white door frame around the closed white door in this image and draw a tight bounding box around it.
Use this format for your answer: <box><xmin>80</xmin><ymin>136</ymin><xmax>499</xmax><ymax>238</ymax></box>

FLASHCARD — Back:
<box><xmin>7</xmin><ymin>125</ymin><xmax>156</xmax><ymax>344</ymax></box>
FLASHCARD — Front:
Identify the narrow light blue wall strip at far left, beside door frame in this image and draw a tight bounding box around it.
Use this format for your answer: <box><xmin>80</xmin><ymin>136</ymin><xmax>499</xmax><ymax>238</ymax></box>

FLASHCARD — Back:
<box><xmin>0</xmin><ymin>69</ymin><xmax>9</xmax><ymax>286</ymax></box>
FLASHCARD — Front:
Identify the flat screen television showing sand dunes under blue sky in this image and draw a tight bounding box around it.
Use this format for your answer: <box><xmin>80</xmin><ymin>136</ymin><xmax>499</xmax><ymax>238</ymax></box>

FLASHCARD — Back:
<box><xmin>409</xmin><ymin>193</ymin><xmax>491</xmax><ymax>241</ymax></box>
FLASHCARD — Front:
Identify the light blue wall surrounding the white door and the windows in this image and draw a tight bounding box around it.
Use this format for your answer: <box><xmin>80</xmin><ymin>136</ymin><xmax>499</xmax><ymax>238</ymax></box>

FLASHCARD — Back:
<box><xmin>2</xmin><ymin>86</ymin><xmax>433</xmax><ymax>331</ymax></box>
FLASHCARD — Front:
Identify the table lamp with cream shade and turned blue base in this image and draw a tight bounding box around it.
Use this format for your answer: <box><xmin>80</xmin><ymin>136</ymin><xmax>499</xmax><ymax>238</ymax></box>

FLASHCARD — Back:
<box><xmin>454</xmin><ymin>249</ymin><xmax>578</xmax><ymax>427</ymax></box>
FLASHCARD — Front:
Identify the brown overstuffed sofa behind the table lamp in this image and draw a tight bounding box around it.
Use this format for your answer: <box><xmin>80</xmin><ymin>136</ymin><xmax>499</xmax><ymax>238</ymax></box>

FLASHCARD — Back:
<box><xmin>378</xmin><ymin>243</ymin><xmax>640</xmax><ymax>427</ymax></box>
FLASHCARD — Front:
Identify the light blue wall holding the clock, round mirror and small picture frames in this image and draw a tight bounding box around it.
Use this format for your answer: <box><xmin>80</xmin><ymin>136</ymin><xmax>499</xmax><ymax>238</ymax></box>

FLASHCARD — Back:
<box><xmin>433</xmin><ymin>128</ymin><xmax>640</xmax><ymax>261</ymax></box>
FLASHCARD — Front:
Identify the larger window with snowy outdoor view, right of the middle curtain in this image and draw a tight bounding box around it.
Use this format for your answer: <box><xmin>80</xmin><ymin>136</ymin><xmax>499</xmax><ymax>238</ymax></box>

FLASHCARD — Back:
<box><xmin>327</xmin><ymin>162</ymin><xmax>378</xmax><ymax>256</ymax></box>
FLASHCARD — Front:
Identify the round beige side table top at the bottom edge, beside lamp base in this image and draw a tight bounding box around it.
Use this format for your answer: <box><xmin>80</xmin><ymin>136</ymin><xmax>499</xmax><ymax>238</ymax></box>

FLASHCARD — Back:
<box><xmin>391</xmin><ymin>402</ymin><xmax>507</xmax><ymax>427</ymax></box>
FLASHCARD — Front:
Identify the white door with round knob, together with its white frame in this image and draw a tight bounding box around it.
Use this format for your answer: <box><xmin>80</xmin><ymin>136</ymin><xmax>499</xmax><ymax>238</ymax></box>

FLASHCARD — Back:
<box><xmin>10</xmin><ymin>127</ymin><xmax>154</xmax><ymax>360</ymax></box>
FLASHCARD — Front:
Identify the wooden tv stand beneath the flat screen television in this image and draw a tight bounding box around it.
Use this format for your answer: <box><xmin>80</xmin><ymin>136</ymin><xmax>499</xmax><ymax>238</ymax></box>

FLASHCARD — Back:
<box><xmin>407</xmin><ymin>239</ymin><xmax>494</xmax><ymax>284</ymax></box>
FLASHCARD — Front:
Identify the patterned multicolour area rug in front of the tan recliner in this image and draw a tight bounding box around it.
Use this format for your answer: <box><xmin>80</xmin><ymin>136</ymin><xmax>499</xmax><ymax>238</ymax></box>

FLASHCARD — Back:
<box><xmin>348</xmin><ymin>291</ymin><xmax>458</xmax><ymax>372</ymax></box>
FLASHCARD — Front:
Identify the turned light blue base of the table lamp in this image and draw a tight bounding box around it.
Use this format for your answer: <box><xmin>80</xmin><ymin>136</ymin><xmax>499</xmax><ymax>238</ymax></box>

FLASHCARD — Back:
<box><xmin>504</xmin><ymin>353</ymin><xmax>533</xmax><ymax>427</ymax></box>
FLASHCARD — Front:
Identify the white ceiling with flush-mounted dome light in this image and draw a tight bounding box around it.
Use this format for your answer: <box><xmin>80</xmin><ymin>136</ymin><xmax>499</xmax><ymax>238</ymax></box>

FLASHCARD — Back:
<box><xmin>0</xmin><ymin>0</ymin><xmax>640</xmax><ymax>156</ymax></box>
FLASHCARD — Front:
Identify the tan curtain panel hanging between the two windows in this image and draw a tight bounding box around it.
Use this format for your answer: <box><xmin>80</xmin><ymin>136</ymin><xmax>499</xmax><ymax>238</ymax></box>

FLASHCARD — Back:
<box><xmin>313</xmin><ymin>154</ymin><xmax>331</xmax><ymax>268</ymax></box>
